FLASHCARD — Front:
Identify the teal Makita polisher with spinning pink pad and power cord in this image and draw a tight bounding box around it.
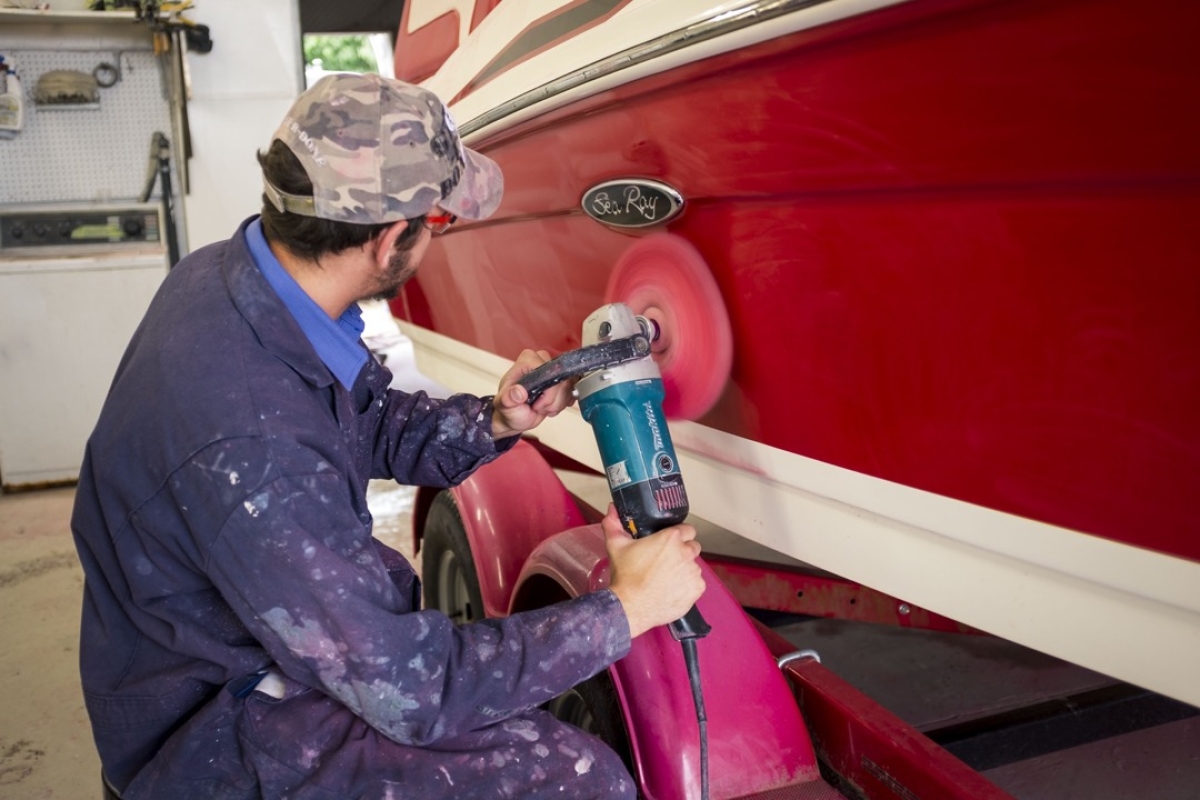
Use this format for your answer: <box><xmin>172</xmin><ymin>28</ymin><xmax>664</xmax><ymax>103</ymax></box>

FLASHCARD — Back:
<box><xmin>520</xmin><ymin>234</ymin><xmax>733</xmax><ymax>798</ymax></box>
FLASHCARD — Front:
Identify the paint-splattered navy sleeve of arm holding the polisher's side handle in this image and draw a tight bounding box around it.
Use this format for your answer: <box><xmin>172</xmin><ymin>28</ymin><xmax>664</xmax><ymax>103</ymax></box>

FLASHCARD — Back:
<box><xmin>360</xmin><ymin>390</ymin><xmax>517</xmax><ymax>487</ymax></box>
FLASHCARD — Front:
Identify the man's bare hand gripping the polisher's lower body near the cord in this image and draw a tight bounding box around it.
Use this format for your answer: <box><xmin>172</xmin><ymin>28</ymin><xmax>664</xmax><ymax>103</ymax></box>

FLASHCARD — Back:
<box><xmin>600</xmin><ymin>505</ymin><xmax>704</xmax><ymax>637</ymax></box>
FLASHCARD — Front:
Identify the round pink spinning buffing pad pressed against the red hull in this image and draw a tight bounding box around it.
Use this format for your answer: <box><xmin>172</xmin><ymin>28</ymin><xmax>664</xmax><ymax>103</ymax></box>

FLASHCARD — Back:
<box><xmin>605</xmin><ymin>234</ymin><xmax>733</xmax><ymax>420</ymax></box>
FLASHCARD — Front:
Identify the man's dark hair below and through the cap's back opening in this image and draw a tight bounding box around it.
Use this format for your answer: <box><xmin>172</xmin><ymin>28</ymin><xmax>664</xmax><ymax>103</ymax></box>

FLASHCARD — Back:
<box><xmin>258</xmin><ymin>139</ymin><xmax>422</xmax><ymax>261</ymax></box>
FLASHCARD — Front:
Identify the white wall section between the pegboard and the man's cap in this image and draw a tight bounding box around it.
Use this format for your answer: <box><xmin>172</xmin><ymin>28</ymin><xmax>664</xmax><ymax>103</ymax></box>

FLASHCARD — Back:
<box><xmin>185</xmin><ymin>0</ymin><xmax>304</xmax><ymax>251</ymax></box>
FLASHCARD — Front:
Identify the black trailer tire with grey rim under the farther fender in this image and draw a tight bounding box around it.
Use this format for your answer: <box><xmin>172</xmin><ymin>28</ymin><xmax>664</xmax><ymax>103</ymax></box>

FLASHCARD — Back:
<box><xmin>421</xmin><ymin>492</ymin><xmax>484</xmax><ymax>625</ymax></box>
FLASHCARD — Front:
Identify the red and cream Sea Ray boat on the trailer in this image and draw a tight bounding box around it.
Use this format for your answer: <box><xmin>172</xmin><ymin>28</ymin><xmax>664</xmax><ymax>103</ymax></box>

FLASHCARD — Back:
<box><xmin>392</xmin><ymin>0</ymin><xmax>1200</xmax><ymax>703</ymax></box>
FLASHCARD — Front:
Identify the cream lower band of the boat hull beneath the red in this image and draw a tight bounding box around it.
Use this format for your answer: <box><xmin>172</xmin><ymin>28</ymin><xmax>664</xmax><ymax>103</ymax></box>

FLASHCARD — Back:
<box><xmin>400</xmin><ymin>321</ymin><xmax>1200</xmax><ymax>705</ymax></box>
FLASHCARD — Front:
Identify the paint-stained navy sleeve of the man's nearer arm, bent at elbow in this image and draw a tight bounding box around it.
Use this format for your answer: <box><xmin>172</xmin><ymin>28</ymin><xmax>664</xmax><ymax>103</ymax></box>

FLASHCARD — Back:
<box><xmin>206</xmin><ymin>473</ymin><xmax>630</xmax><ymax>745</ymax></box>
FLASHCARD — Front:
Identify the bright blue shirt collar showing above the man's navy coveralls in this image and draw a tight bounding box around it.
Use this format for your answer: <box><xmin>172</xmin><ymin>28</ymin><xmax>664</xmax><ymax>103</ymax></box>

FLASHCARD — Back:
<box><xmin>246</xmin><ymin>219</ymin><xmax>367</xmax><ymax>390</ymax></box>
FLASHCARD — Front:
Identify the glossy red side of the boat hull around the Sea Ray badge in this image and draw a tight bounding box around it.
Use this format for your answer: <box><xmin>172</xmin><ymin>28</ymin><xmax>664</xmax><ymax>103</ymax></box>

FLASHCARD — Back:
<box><xmin>394</xmin><ymin>0</ymin><xmax>1200</xmax><ymax>559</ymax></box>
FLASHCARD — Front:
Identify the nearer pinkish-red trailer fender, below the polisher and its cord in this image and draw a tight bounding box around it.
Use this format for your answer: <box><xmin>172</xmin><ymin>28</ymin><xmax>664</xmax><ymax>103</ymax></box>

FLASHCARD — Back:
<box><xmin>512</xmin><ymin>524</ymin><xmax>820</xmax><ymax>800</ymax></box>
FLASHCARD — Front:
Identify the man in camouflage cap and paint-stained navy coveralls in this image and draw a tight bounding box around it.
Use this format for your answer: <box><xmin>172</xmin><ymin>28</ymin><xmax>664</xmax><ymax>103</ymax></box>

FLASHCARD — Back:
<box><xmin>72</xmin><ymin>76</ymin><xmax>703</xmax><ymax>800</ymax></box>
